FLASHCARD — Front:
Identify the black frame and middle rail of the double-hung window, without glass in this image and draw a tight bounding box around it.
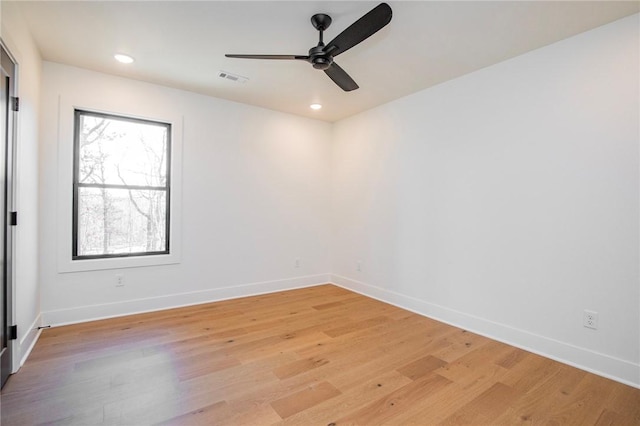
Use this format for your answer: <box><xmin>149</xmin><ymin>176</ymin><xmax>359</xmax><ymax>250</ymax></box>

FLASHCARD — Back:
<box><xmin>71</xmin><ymin>108</ymin><xmax>172</xmax><ymax>260</ymax></box>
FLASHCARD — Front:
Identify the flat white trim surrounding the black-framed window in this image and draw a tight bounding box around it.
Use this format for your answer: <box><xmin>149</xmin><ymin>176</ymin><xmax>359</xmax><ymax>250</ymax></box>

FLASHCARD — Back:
<box><xmin>57</xmin><ymin>96</ymin><xmax>184</xmax><ymax>273</ymax></box>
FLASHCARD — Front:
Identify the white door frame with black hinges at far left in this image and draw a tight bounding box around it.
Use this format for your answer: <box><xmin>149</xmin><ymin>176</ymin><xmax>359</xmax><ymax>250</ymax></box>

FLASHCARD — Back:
<box><xmin>0</xmin><ymin>38</ymin><xmax>19</xmax><ymax>388</ymax></box>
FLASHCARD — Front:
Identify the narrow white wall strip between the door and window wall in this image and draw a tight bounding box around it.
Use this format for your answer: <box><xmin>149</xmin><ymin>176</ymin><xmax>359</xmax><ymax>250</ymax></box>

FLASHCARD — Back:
<box><xmin>0</xmin><ymin>2</ymin><xmax>42</xmax><ymax>370</ymax></box>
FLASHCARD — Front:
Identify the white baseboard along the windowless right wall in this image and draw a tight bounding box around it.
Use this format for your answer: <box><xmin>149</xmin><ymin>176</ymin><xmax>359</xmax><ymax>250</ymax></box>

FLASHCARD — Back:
<box><xmin>330</xmin><ymin>274</ymin><xmax>640</xmax><ymax>388</ymax></box>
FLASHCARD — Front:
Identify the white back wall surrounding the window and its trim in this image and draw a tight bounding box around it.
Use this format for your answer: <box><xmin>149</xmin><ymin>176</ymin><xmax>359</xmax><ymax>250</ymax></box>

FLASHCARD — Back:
<box><xmin>40</xmin><ymin>62</ymin><xmax>331</xmax><ymax>324</ymax></box>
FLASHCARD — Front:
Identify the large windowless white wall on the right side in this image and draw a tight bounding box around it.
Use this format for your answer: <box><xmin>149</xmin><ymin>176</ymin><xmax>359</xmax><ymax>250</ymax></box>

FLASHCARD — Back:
<box><xmin>331</xmin><ymin>15</ymin><xmax>640</xmax><ymax>386</ymax></box>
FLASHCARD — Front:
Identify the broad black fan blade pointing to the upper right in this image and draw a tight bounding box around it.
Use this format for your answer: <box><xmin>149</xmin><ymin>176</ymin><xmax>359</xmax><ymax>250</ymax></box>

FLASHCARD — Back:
<box><xmin>324</xmin><ymin>3</ymin><xmax>392</xmax><ymax>56</ymax></box>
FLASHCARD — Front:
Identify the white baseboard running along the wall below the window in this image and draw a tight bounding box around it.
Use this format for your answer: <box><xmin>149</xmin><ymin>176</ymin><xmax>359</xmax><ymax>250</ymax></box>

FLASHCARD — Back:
<box><xmin>42</xmin><ymin>274</ymin><xmax>330</xmax><ymax>327</ymax></box>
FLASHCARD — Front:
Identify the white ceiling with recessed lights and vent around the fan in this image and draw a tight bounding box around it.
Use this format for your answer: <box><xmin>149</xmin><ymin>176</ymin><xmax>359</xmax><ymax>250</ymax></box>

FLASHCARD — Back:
<box><xmin>10</xmin><ymin>0</ymin><xmax>640</xmax><ymax>121</ymax></box>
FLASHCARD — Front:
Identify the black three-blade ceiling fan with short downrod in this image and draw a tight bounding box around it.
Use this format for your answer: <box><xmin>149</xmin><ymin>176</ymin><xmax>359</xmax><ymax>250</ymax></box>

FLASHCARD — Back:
<box><xmin>225</xmin><ymin>3</ymin><xmax>392</xmax><ymax>92</ymax></box>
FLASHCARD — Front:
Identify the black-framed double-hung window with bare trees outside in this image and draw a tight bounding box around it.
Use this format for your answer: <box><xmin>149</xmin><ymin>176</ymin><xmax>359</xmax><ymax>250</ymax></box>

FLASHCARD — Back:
<box><xmin>72</xmin><ymin>109</ymin><xmax>171</xmax><ymax>260</ymax></box>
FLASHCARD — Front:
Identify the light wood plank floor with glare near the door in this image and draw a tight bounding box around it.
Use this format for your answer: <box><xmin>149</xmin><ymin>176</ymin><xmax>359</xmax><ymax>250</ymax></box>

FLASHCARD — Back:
<box><xmin>1</xmin><ymin>285</ymin><xmax>640</xmax><ymax>426</ymax></box>
